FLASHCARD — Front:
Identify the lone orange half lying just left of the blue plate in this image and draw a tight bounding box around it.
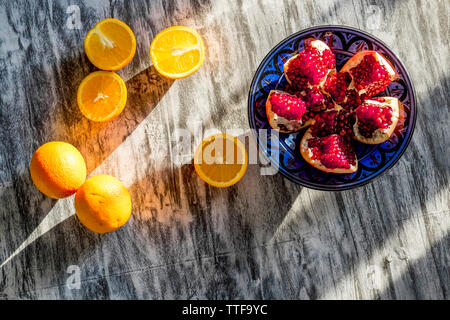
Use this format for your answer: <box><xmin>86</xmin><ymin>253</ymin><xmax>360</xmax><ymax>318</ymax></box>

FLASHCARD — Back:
<box><xmin>194</xmin><ymin>133</ymin><xmax>248</xmax><ymax>188</ymax></box>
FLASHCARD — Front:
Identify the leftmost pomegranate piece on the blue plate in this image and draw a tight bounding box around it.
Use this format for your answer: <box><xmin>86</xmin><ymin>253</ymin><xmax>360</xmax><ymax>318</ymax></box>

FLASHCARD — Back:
<box><xmin>266</xmin><ymin>90</ymin><xmax>312</xmax><ymax>133</ymax></box>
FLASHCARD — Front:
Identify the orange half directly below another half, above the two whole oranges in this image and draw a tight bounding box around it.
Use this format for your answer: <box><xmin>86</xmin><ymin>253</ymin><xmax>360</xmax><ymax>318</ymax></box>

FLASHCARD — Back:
<box><xmin>77</xmin><ymin>71</ymin><xmax>127</xmax><ymax>122</ymax></box>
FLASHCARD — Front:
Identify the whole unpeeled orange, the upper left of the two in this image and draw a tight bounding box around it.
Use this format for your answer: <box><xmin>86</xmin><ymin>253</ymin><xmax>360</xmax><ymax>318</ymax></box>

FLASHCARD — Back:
<box><xmin>30</xmin><ymin>141</ymin><xmax>86</xmax><ymax>199</ymax></box>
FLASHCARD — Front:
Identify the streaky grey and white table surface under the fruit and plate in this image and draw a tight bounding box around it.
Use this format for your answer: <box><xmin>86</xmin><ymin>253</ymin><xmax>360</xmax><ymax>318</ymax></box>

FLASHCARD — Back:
<box><xmin>0</xmin><ymin>0</ymin><xmax>450</xmax><ymax>299</ymax></box>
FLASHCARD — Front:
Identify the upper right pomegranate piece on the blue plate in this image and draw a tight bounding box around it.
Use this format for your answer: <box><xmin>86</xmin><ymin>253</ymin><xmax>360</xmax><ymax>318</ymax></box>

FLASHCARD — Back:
<box><xmin>340</xmin><ymin>51</ymin><xmax>398</xmax><ymax>98</ymax></box>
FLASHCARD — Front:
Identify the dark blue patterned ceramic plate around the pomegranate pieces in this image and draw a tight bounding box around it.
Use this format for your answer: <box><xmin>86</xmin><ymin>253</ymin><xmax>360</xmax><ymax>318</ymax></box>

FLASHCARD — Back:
<box><xmin>248</xmin><ymin>26</ymin><xmax>416</xmax><ymax>191</ymax></box>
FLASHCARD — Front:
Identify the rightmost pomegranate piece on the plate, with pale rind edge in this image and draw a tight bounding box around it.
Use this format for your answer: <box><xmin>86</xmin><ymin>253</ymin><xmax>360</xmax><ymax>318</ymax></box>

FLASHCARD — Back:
<box><xmin>353</xmin><ymin>97</ymin><xmax>400</xmax><ymax>144</ymax></box>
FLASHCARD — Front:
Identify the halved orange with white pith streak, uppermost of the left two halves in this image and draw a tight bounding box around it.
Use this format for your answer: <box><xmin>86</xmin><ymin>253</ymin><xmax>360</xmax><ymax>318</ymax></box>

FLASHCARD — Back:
<box><xmin>84</xmin><ymin>18</ymin><xmax>136</xmax><ymax>70</ymax></box>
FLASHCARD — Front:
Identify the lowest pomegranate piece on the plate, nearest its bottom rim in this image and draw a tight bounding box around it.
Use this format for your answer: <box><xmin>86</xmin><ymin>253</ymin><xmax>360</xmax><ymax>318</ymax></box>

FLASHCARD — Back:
<box><xmin>300</xmin><ymin>129</ymin><xmax>358</xmax><ymax>173</ymax></box>
